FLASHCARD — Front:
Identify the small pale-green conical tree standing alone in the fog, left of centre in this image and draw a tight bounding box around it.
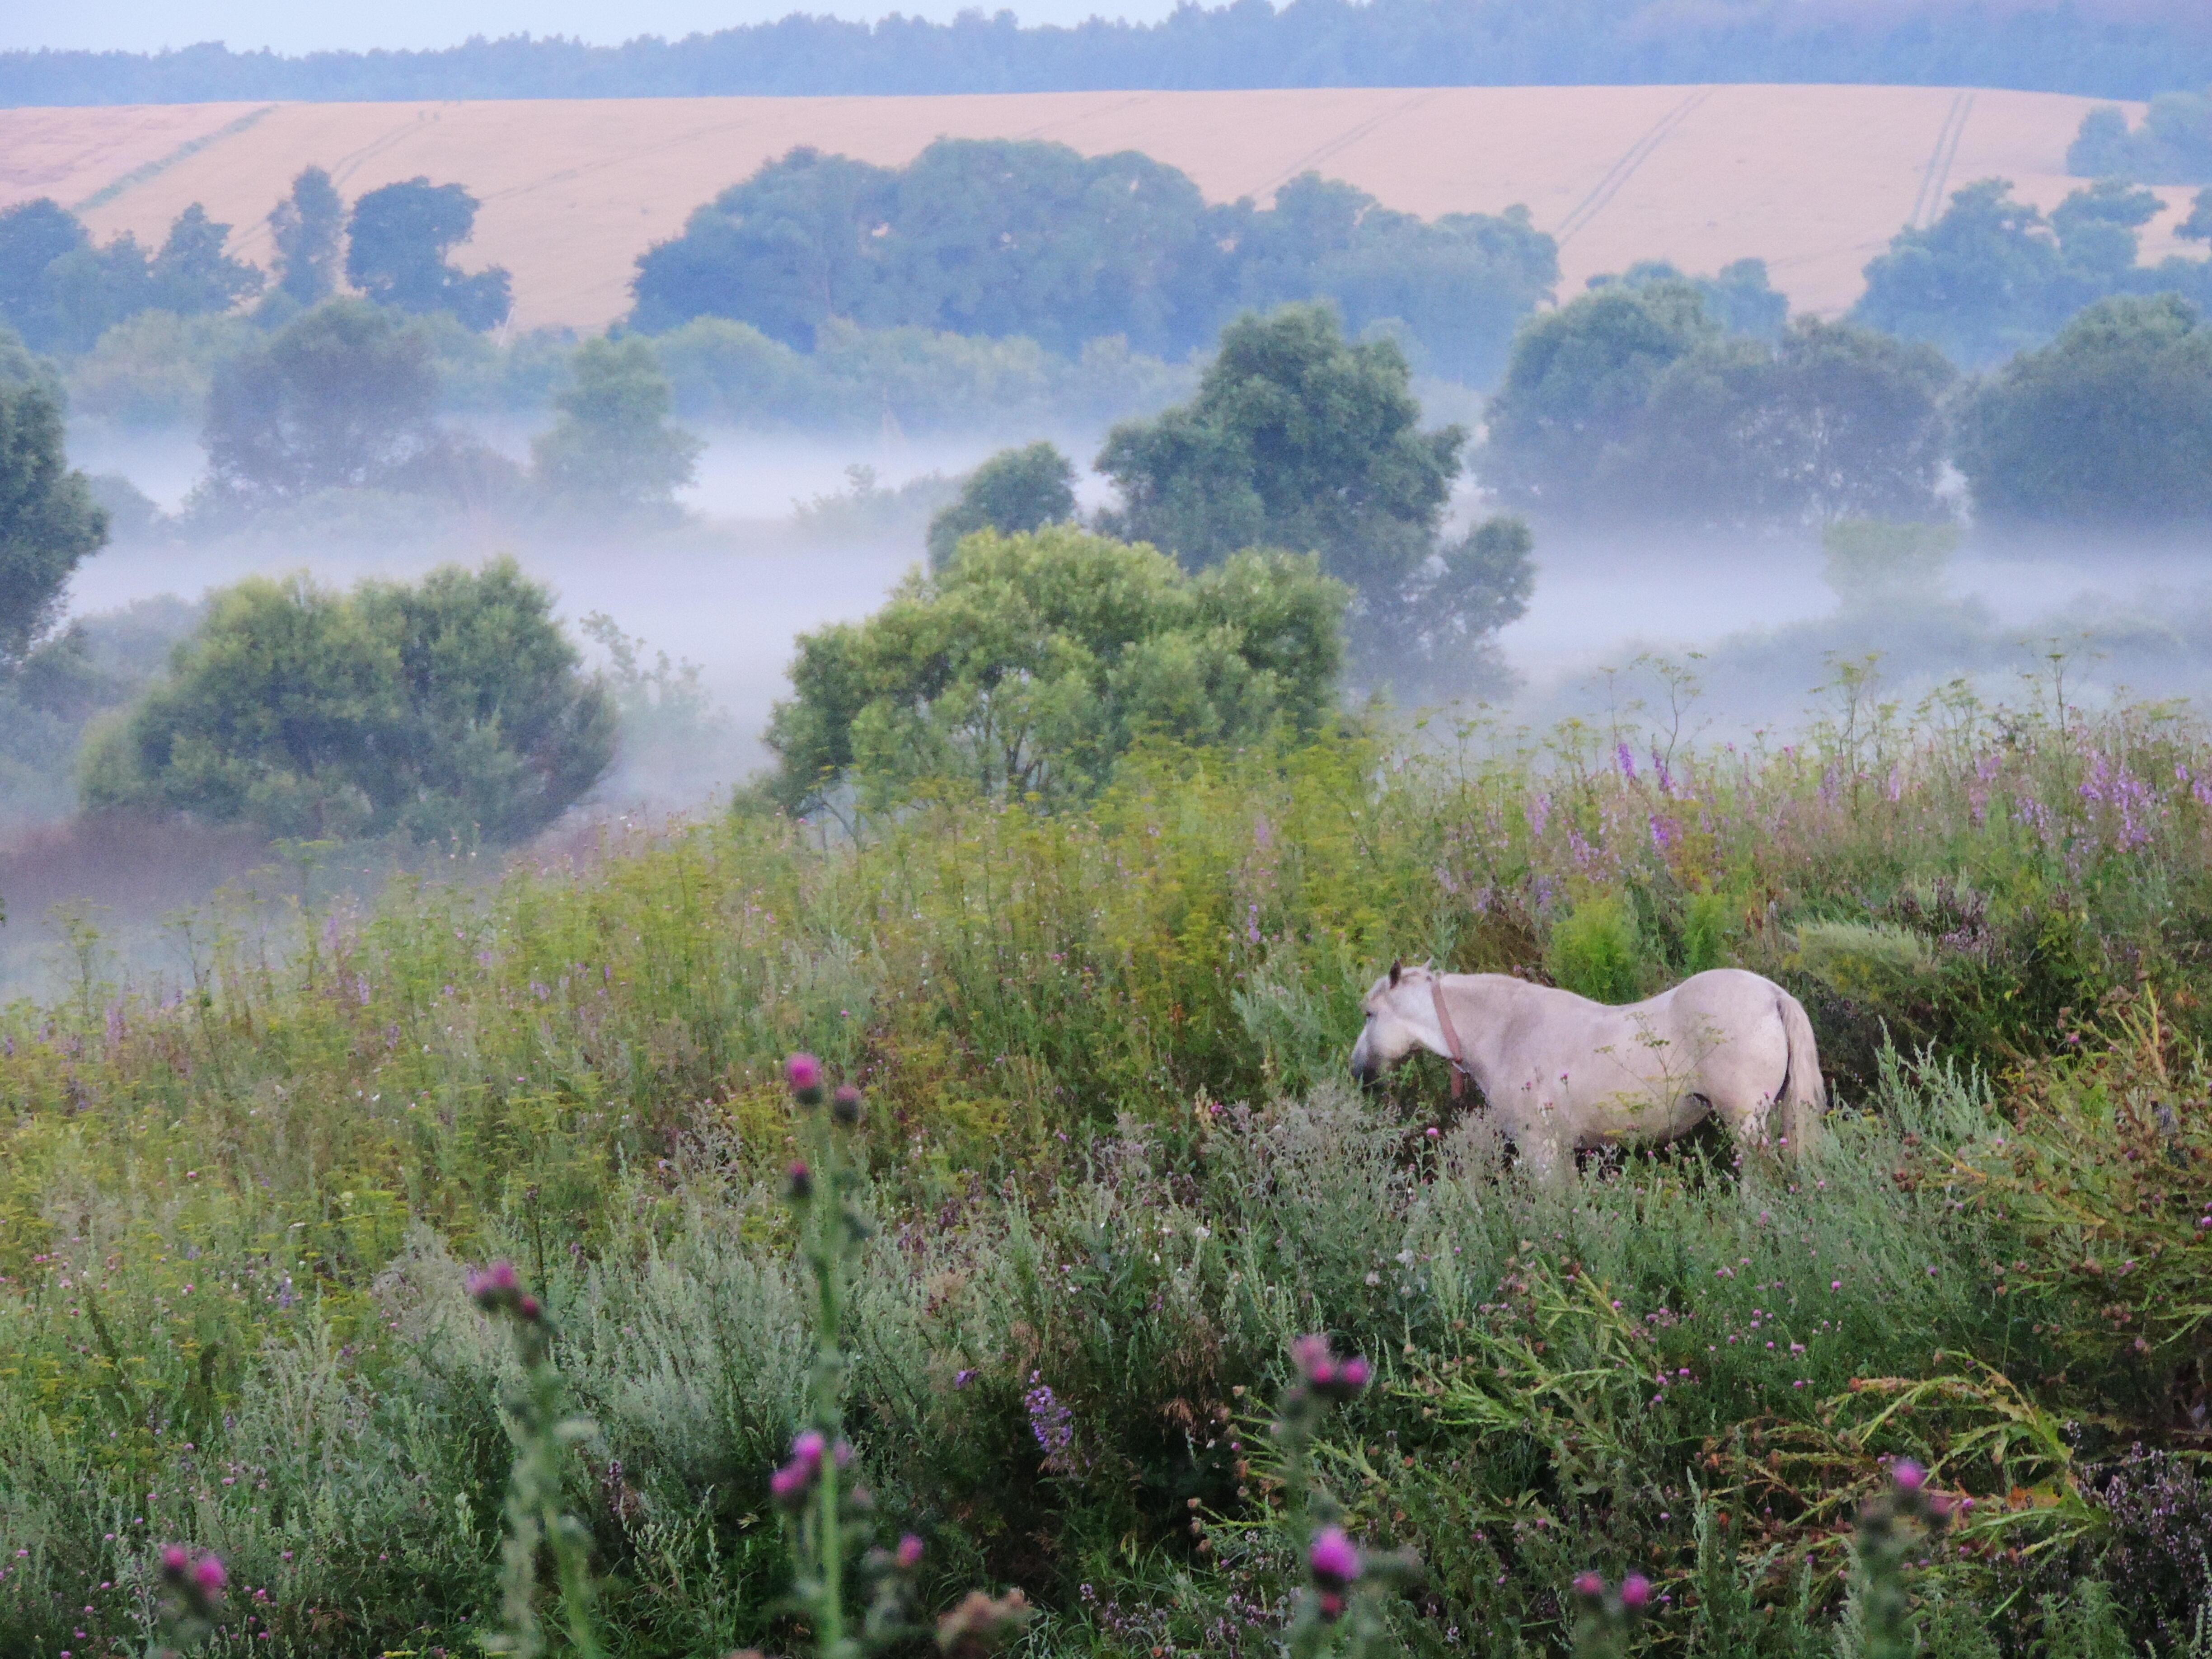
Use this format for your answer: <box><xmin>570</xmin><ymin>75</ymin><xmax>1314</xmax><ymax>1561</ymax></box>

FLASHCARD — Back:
<box><xmin>531</xmin><ymin>336</ymin><xmax>701</xmax><ymax>509</ymax></box>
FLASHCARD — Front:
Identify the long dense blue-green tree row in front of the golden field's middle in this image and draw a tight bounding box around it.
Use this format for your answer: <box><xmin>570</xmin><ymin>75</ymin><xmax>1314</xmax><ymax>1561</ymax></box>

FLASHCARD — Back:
<box><xmin>633</xmin><ymin>139</ymin><xmax>1560</xmax><ymax>380</ymax></box>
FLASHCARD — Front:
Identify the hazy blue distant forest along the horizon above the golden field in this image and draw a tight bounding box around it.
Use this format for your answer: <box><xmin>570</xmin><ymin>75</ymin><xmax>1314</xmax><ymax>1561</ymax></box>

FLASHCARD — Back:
<box><xmin>0</xmin><ymin>0</ymin><xmax>2212</xmax><ymax>106</ymax></box>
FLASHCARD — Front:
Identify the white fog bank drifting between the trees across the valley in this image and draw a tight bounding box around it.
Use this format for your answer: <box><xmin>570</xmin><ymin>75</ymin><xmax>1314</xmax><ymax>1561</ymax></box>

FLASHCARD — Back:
<box><xmin>17</xmin><ymin>427</ymin><xmax>2212</xmax><ymax>998</ymax></box>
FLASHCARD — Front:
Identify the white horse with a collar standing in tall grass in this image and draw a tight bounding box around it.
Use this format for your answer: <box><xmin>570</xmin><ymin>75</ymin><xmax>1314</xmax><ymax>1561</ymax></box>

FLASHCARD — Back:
<box><xmin>1351</xmin><ymin>962</ymin><xmax>1827</xmax><ymax>1175</ymax></box>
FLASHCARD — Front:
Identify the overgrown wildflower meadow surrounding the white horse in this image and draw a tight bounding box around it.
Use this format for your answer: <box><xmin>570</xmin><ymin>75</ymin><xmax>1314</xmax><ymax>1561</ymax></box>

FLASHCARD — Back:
<box><xmin>0</xmin><ymin>681</ymin><xmax>2212</xmax><ymax>1659</ymax></box>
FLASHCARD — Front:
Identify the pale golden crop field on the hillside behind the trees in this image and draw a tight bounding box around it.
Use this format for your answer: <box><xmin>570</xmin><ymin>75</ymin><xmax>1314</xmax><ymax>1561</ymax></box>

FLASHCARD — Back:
<box><xmin>0</xmin><ymin>86</ymin><xmax>2188</xmax><ymax>338</ymax></box>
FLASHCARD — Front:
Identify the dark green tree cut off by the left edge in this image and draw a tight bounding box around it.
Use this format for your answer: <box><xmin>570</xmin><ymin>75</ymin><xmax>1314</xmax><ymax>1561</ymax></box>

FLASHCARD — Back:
<box><xmin>0</xmin><ymin>356</ymin><xmax>108</xmax><ymax>675</ymax></box>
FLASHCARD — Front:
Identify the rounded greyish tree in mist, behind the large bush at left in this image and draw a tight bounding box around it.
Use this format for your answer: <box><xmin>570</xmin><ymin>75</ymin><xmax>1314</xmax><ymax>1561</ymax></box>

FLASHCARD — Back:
<box><xmin>206</xmin><ymin>299</ymin><xmax>438</xmax><ymax>500</ymax></box>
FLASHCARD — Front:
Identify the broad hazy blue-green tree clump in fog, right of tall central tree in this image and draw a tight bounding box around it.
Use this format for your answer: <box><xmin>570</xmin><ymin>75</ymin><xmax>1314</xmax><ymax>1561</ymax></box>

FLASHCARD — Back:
<box><xmin>1476</xmin><ymin>285</ymin><xmax>1951</xmax><ymax>524</ymax></box>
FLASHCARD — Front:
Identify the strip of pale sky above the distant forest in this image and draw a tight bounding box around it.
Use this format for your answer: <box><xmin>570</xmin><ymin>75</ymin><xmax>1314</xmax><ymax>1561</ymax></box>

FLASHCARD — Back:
<box><xmin>0</xmin><ymin>0</ymin><xmax>1172</xmax><ymax>53</ymax></box>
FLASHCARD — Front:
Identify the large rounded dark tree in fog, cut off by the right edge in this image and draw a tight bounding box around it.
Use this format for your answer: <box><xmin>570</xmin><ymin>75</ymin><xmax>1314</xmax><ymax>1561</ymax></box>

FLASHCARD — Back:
<box><xmin>1958</xmin><ymin>294</ymin><xmax>2212</xmax><ymax>524</ymax></box>
